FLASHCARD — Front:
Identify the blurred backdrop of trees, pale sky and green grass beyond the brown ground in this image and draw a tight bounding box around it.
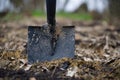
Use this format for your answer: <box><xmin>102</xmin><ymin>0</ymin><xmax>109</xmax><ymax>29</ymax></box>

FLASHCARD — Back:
<box><xmin>0</xmin><ymin>0</ymin><xmax>120</xmax><ymax>25</ymax></box>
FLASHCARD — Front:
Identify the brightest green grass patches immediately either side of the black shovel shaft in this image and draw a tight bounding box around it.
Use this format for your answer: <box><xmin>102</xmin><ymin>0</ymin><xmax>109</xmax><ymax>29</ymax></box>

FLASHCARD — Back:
<box><xmin>32</xmin><ymin>11</ymin><xmax>92</xmax><ymax>20</ymax></box>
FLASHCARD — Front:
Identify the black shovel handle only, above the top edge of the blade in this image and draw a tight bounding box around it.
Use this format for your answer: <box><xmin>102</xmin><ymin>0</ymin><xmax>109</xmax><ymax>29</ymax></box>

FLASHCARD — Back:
<box><xmin>46</xmin><ymin>0</ymin><xmax>56</xmax><ymax>28</ymax></box>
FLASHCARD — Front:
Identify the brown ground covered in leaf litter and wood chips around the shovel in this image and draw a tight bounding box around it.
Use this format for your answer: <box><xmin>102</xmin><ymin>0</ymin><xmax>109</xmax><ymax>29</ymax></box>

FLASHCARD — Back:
<box><xmin>0</xmin><ymin>18</ymin><xmax>120</xmax><ymax>80</ymax></box>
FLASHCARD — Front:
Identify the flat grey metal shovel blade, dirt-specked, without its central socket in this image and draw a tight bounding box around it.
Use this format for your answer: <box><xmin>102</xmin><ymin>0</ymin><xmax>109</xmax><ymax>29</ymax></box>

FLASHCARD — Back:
<box><xmin>27</xmin><ymin>26</ymin><xmax>75</xmax><ymax>63</ymax></box>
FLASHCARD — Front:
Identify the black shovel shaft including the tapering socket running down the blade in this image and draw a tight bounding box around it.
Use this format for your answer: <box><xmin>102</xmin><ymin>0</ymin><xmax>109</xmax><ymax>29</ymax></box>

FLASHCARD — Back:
<box><xmin>46</xmin><ymin>0</ymin><xmax>56</xmax><ymax>55</ymax></box>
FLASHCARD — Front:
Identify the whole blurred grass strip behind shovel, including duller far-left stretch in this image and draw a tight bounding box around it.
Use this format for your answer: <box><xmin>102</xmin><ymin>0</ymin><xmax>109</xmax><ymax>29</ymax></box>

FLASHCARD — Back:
<box><xmin>2</xmin><ymin>10</ymin><xmax>92</xmax><ymax>21</ymax></box>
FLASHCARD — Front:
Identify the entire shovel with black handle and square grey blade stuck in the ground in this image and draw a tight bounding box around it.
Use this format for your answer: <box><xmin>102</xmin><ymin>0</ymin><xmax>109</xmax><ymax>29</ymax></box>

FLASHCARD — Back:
<box><xmin>27</xmin><ymin>0</ymin><xmax>75</xmax><ymax>63</ymax></box>
